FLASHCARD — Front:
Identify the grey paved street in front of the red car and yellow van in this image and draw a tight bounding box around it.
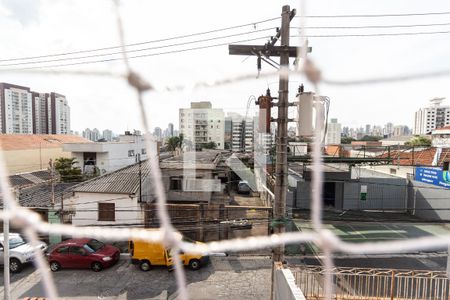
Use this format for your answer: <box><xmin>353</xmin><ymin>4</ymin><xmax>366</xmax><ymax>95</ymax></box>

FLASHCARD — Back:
<box><xmin>0</xmin><ymin>256</ymin><xmax>271</xmax><ymax>299</ymax></box>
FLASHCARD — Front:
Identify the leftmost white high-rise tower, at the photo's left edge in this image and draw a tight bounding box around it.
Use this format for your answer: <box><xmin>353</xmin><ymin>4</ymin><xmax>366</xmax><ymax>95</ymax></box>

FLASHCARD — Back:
<box><xmin>0</xmin><ymin>83</ymin><xmax>33</xmax><ymax>134</ymax></box>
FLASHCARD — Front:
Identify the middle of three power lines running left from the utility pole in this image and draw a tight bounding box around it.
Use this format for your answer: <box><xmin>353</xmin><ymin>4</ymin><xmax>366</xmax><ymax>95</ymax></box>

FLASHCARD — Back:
<box><xmin>0</xmin><ymin>27</ymin><xmax>275</xmax><ymax>67</ymax></box>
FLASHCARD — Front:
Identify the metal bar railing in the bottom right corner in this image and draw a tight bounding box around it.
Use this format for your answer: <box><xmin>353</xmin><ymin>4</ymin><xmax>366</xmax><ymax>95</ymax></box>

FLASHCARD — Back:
<box><xmin>291</xmin><ymin>266</ymin><xmax>449</xmax><ymax>300</ymax></box>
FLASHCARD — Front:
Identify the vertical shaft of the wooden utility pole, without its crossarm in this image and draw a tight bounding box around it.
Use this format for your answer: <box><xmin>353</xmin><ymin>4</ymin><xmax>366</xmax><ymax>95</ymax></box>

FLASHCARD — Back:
<box><xmin>273</xmin><ymin>5</ymin><xmax>290</xmax><ymax>262</ymax></box>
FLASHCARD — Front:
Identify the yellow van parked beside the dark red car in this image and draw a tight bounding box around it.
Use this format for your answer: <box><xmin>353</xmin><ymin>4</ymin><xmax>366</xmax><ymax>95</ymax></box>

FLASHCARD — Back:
<box><xmin>128</xmin><ymin>233</ymin><xmax>209</xmax><ymax>272</ymax></box>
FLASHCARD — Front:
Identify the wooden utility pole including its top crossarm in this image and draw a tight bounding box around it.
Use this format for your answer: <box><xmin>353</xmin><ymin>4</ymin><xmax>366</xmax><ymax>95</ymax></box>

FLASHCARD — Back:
<box><xmin>228</xmin><ymin>5</ymin><xmax>311</xmax><ymax>262</ymax></box>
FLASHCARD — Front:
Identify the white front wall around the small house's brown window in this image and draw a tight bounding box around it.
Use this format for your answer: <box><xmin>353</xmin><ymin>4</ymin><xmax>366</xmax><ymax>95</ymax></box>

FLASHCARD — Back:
<box><xmin>64</xmin><ymin>192</ymin><xmax>144</xmax><ymax>226</ymax></box>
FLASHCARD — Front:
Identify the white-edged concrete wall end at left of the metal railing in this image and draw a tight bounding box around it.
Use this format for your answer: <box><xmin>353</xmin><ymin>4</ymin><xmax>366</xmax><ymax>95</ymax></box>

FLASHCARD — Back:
<box><xmin>273</xmin><ymin>267</ymin><xmax>306</xmax><ymax>300</ymax></box>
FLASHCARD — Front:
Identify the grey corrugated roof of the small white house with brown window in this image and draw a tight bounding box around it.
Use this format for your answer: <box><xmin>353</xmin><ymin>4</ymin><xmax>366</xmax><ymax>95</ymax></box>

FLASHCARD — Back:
<box><xmin>71</xmin><ymin>160</ymin><xmax>150</xmax><ymax>194</ymax></box>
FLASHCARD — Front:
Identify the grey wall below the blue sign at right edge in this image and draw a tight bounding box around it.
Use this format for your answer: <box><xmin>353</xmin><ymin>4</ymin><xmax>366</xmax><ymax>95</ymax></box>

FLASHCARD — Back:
<box><xmin>408</xmin><ymin>180</ymin><xmax>450</xmax><ymax>221</ymax></box>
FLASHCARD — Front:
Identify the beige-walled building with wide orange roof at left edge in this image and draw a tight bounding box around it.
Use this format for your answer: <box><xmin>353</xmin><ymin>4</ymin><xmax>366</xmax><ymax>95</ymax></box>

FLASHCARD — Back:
<box><xmin>0</xmin><ymin>134</ymin><xmax>92</xmax><ymax>175</ymax></box>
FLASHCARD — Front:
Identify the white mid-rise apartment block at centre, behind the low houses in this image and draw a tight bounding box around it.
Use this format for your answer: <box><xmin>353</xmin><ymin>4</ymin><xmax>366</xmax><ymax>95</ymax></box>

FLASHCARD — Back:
<box><xmin>179</xmin><ymin>101</ymin><xmax>225</xmax><ymax>149</ymax></box>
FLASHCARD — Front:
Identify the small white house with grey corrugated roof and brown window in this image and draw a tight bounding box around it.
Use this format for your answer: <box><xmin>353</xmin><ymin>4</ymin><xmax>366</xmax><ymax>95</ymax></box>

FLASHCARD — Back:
<box><xmin>64</xmin><ymin>161</ymin><xmax>154</xmax><ymax>226</ymax></box>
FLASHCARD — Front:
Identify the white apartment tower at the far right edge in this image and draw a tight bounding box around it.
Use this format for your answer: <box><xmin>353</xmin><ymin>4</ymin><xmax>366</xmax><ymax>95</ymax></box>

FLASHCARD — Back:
<box><xmin>414</xmin><ymin>98</ymin><xmax>450</xmax><ymax>135</ymax></box>
